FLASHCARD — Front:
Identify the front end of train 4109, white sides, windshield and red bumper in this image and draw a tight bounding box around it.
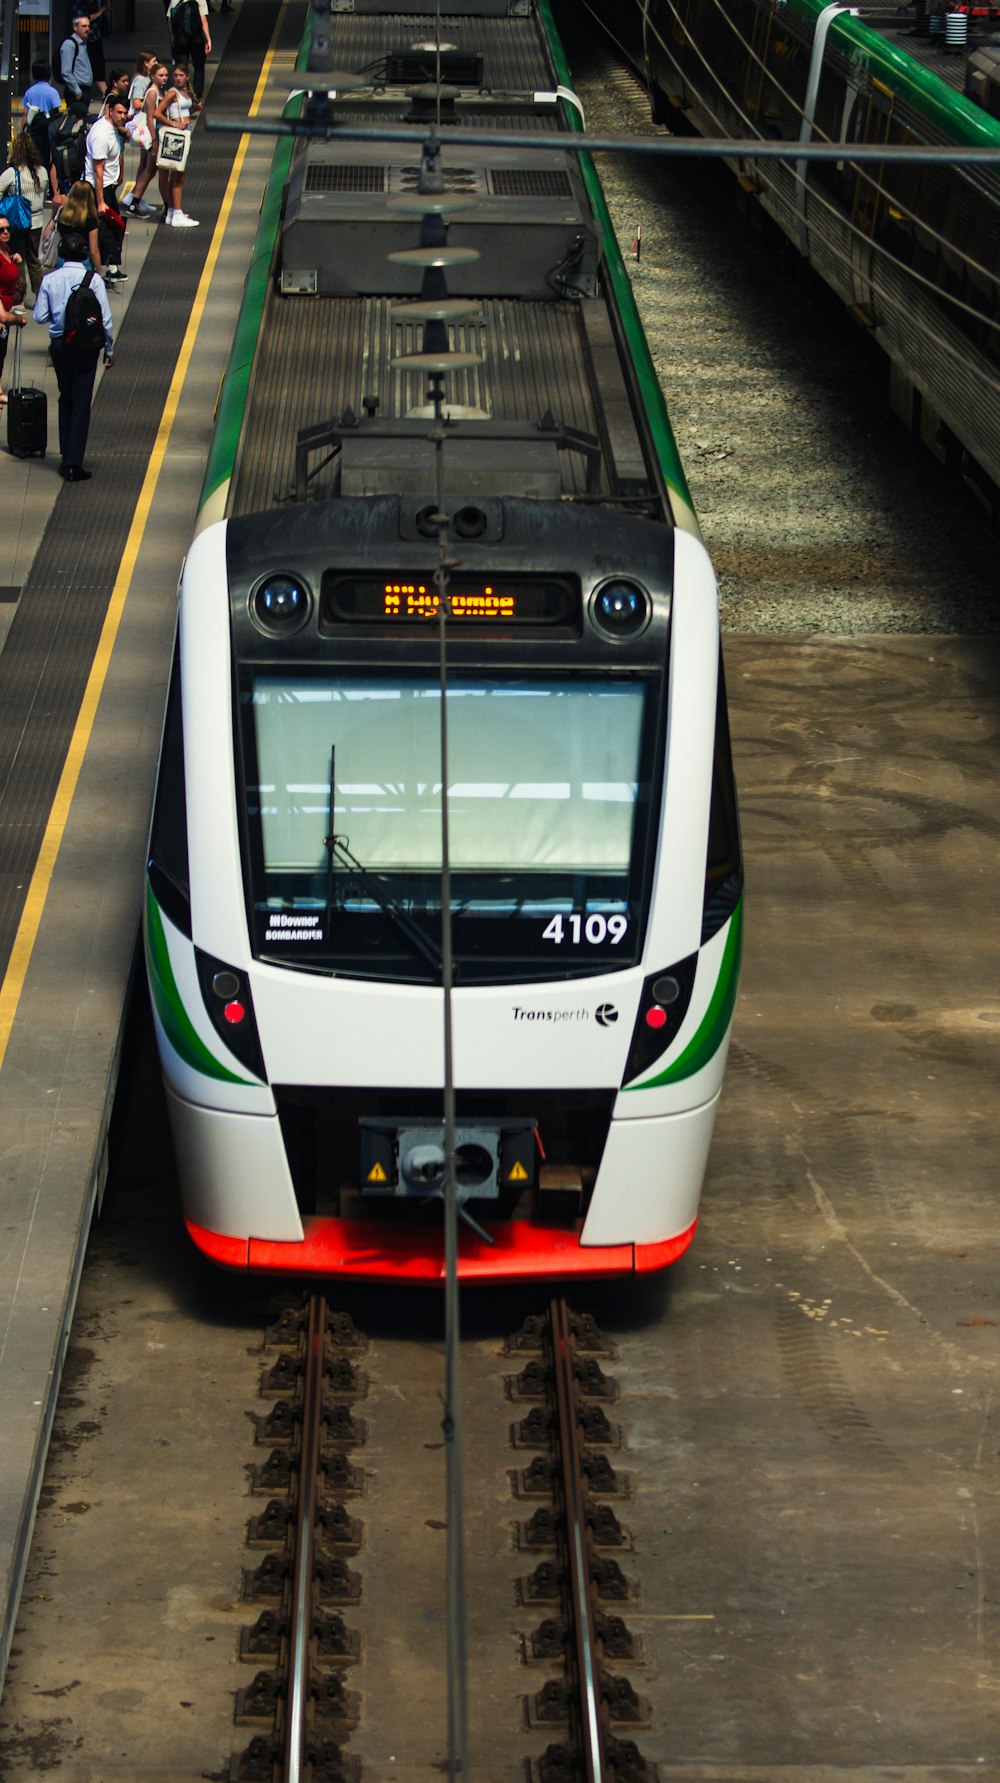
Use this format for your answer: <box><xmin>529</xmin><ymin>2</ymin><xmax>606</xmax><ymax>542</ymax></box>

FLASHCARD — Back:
<box><xmin>146</xmin><ymin>497</ymin><xmax>742</xmax><ymax>1282</ymax></box>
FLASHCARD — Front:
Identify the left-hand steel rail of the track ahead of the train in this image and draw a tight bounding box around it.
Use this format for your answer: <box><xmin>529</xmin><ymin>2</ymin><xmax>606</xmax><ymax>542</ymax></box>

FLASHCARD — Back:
<box><xmin>282</xmin><ymin>1294</ymin><xmax>326</xmax><ymax>1783</ymax></box>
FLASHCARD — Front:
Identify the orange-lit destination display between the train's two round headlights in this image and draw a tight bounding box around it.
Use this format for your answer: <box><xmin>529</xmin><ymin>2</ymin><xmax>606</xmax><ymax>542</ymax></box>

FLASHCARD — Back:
<box><xmin>323</xmin><ymin>572</ymin><xmax>579</xmax><ymax>626</ymax></box>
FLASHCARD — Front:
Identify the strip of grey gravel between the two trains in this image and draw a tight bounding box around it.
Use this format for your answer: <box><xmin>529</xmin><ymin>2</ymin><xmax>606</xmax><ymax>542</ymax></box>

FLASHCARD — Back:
<box><xmin>569</xmin><ymin>43</ymin><xmax>1000</xmax><ymax>635</ymax></box>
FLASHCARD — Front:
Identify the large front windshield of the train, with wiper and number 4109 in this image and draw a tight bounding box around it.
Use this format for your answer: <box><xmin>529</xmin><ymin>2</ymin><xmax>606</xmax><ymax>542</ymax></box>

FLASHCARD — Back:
<box><xmin>242</xmin><ymin>670</ymin><xmax>656</xmax><ymax>982</ymax></box>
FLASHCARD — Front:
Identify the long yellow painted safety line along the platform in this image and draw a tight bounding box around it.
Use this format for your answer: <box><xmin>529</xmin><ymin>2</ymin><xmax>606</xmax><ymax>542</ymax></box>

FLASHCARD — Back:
<box><xmin>0</xmin><ymin>0</ymin><xmax>289</xmax><ymax>1066</ymax></box>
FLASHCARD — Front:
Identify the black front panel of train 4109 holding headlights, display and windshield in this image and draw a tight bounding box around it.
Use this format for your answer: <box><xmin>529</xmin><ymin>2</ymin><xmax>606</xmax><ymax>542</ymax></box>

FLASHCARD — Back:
<box><xmin>228</xmin><ymin>497</ymin><xmax>672</xmax><ymax>982</ymax></box>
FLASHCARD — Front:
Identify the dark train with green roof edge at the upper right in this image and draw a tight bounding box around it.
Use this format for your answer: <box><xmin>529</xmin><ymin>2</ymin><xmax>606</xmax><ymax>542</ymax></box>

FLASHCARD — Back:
<box><xmin>585</xmin><ymin>0</ymin><xmax>1000</xmax><ymax>515</ymax></box>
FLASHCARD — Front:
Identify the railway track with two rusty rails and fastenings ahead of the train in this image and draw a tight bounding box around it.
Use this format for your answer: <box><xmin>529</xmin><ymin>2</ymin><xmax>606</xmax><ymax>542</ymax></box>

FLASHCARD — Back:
<box><xmin>228</xmin><ymin>1294</ymin><xmax>656</xmax><ymax>1783</ymax></box>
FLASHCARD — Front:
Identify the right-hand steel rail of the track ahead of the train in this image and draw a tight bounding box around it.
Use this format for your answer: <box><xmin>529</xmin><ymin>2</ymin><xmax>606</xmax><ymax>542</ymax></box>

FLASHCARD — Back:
<box><xmin>549</xmin><ymin>1300</ymin><xmax>608</xmax><ymax>1783</ymax></box>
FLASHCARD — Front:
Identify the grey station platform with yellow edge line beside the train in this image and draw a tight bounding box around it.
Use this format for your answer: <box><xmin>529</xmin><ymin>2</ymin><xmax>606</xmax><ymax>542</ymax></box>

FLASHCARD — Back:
<box><xmin>0</xmin><ymin>0</ymin><xmax>305</xmax><ymax>1680</ymax></box>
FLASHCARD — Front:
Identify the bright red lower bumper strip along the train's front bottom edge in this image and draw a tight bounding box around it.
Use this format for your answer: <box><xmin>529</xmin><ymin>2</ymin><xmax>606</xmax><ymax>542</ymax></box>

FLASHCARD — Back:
<box><xmin>185</xmin><ymin>1220</ymin><xmax>697</xmax><ymax>1284</ymax></box>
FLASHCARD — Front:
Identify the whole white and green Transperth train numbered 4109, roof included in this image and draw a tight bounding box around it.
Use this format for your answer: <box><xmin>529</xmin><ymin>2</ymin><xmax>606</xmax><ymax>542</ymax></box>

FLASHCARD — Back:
<box><xmin>144</xmin><ymin>0</ymin><xmax>743</xmax><ymax>1284</ymax></box>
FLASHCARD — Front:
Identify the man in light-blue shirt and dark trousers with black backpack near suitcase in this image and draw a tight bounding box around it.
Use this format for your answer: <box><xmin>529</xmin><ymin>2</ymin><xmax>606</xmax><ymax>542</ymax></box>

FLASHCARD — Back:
<box><xmin>34</xmin><ymin>235</ymin><xmax>114</xmax><ymax>483</ymax></box>
